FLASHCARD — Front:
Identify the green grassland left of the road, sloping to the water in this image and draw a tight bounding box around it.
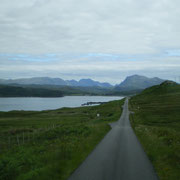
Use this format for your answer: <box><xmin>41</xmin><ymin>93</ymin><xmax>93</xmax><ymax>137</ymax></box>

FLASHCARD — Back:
<box><xmin>0</xmin><ymin>100</ymin><xmax>124</xmax><ymax>180</ymax></box>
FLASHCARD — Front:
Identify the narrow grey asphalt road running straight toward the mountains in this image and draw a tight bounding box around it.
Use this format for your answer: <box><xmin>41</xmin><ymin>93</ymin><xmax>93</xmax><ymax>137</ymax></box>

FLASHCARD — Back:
<box><xmin>69</xmin><ymin>99</ymin><xmax>158</xmax><ymax>180</ymax></box>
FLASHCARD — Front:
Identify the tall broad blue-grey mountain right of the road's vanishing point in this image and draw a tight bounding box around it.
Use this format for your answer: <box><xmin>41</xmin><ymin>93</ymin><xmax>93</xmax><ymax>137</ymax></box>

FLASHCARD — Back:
<box><xmin>114</xmin><ymin>75</ymin><xmax>165</xmax><ymax>91</ymax></box>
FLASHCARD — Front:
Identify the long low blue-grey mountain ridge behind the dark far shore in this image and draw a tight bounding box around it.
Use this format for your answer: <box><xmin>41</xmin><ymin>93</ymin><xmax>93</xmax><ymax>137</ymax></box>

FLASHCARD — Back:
<box><xmin>0</xmin><ymin>77</ymin><xmax>112</xmax><ymax>88</ymax></box>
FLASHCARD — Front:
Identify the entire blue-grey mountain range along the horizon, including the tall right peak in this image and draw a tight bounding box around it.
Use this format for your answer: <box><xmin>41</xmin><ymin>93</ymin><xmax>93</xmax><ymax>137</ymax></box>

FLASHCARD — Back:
<box><xmin>0</xmin><ymin>75</ymin><xmax>165</xmax><ymax>95</ymax></box>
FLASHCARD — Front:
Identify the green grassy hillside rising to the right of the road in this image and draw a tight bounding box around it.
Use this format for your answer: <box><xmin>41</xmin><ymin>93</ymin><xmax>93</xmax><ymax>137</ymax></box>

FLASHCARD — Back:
<box><xmin>130</xmin><ymin>81</ymin><xmax>180</xmax><ymax>180</ymax></box>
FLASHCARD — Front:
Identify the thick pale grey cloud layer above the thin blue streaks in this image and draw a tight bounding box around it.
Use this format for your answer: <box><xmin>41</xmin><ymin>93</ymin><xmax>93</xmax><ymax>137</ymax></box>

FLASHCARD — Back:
<box><xmin>0</xmin><ymin>0</ymin><xmax>180</xmax><ymax>53</ymax></box>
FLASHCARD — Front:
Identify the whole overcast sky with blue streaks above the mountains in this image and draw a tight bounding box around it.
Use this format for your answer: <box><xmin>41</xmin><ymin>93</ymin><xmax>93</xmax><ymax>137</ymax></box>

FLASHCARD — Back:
<box><xmin>0</xmin><ymin>0</ymin><xmax>180</xmax><ymax>84</ymax></box>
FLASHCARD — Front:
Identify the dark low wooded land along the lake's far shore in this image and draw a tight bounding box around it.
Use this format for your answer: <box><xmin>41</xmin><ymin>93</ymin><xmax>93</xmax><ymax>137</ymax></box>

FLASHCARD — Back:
<box><xmin>0</xmin><ymin>84</ymin><xmax>115</xmax><ymax>97</ymax></box>
